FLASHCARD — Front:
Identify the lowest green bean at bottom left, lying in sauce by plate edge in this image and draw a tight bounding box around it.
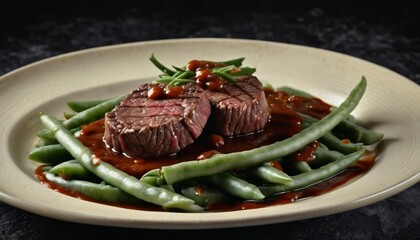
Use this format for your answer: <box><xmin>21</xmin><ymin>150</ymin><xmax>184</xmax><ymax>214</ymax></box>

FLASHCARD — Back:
<box><xmin>44</xmin><ymin>172</ymin><xmax>144</xmax><ymax>204</ymax></box>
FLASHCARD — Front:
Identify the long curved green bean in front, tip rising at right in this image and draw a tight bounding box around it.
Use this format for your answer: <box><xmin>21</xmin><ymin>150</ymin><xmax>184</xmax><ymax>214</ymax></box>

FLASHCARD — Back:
<box><xmin>153</xmin><ymin>77</ymin><xmax>367</xmax><ymax>184</ymax></box>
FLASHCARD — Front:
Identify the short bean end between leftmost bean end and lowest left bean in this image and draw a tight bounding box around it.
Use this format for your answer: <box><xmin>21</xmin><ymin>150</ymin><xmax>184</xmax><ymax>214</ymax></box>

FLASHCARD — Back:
<box><xmin>49</xmin><ymin>159</ymin><xmax>93</xmax><ymax>179</ymax></box>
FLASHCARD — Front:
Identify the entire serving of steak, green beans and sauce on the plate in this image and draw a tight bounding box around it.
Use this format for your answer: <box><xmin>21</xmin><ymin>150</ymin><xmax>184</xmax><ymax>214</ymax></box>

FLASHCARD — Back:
<box><xmin>28</xmin><ymin>54</ymin><xmax>383</xmax><ymax>212</ymax></box>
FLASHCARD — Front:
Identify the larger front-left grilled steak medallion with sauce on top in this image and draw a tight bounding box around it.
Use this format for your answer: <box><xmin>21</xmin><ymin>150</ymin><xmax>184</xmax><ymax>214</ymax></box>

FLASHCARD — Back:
<box><xmin>104</xmin><ymin>83</ymin><xmax>211</xmax><ymax>158</ymax></box>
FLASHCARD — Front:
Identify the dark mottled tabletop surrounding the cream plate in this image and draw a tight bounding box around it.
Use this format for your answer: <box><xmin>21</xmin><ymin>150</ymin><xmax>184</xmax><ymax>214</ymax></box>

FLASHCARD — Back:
<box><xmin>0</xmin><ymin>0</ymin><xmax>420</xmax><ymax>239</ymax></box>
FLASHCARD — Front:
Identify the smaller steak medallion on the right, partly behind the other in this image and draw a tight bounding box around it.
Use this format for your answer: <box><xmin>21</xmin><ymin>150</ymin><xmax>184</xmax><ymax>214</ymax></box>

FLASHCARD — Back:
<box><xmin>206</xmin><ymin>75</ymin><xmax>270</xmax><ymax>136</ymax></box>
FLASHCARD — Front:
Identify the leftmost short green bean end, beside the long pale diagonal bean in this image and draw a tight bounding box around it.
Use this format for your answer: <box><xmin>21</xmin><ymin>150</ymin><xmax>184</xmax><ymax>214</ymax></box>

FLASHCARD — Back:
<box><xmin>28</xmin><ymin>144</ymin><xmax>73</xmax><ymax>164</ymax></box>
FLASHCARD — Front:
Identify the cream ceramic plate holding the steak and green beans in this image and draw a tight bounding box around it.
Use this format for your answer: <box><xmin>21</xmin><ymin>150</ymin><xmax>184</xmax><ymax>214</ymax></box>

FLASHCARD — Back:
<box><xmin>0</xmin><ymin>39</ymin><xmax>420</xmax><ymax>229</ymax></box>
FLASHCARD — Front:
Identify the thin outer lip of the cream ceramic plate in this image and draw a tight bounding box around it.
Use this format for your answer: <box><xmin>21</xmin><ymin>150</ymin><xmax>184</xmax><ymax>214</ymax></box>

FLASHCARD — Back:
<box><xmin>0</xmin><ymin>38</ymin><xmax>420</xmax><ymax>229</ymax></box>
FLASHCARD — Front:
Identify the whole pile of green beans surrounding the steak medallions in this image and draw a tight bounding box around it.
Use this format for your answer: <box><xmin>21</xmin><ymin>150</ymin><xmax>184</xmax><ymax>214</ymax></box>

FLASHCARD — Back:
<box><xmin>28</xmin><ymin>72</ymin><xmax>383</xmax><ymax>212</ymax></box>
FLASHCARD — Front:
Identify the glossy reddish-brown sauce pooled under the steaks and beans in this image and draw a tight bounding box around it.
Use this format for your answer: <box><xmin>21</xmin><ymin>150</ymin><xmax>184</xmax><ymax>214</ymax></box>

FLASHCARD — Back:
<box><xmin>36</xmin><ymin>87</ymin><xmax>376</xmax><ymax>211</ymax></box>
